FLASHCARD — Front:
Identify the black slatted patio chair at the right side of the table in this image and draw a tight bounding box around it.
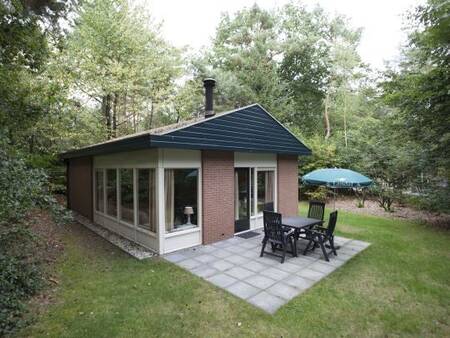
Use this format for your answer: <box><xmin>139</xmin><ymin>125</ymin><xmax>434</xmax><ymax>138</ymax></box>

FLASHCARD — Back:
<box><xmin>303</xmin><ymin>211</ymin><xmax>337</xmax><ymax>262</ymax></box>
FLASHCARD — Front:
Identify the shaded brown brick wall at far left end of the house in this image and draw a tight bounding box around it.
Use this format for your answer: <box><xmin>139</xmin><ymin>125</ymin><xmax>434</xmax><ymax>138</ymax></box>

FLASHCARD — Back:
<box><xmin>67</xmin><ymin>157</ymin><xmax>93</xmax><ymax>220</ymax></box>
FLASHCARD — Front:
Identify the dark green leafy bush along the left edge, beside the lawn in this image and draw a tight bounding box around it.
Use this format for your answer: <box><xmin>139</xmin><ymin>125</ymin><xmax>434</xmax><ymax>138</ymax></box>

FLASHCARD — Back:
<box><xmin>0</xmin><ymin>149</ymin><xmax>70</xmax><ymax>336</ymax></box>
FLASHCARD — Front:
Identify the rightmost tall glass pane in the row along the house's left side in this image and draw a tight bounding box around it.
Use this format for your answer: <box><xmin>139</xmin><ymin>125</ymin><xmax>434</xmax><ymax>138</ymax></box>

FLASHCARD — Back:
<box><xmin>137</xmin><ymin>169</ymin><xmax>156</xmax><ymax>232</ymax></box>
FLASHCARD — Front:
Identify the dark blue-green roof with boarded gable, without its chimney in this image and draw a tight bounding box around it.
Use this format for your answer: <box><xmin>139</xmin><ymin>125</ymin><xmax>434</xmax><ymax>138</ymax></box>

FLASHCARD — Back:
<box><xmin>61</xmin><ymin>104</ymin><xmax>311</xmax><ymax>159</ymax></box>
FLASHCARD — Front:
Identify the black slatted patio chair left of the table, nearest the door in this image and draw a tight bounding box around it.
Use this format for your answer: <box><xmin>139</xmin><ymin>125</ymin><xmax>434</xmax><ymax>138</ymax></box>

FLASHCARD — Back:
<box><xmin>260</xmin><ymin>210</ymin><xmax>297</xmax><ymax>263</ymax></box>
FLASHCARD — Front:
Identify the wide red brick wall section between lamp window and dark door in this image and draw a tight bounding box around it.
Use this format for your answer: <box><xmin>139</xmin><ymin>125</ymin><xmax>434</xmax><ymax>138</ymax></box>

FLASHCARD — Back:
<box><xmin>202</xmin><ymin>151</ymin><xmax>234</xmax><ymax>244</ymax></box>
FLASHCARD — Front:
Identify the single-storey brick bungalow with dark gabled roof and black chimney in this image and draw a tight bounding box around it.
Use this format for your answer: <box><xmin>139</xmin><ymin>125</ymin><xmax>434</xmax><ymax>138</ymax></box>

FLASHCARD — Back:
<box><xmin>61</xmin><ymin>79</ymin><xmax>310</xmax><ymax>254</ymax></box>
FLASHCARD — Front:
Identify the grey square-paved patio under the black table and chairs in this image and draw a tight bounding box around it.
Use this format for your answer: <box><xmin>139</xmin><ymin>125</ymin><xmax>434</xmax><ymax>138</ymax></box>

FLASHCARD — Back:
<box><xmin>163</xmin><ymin>231</ymin><xmax>370</xmax><ymax>314</ymax></box>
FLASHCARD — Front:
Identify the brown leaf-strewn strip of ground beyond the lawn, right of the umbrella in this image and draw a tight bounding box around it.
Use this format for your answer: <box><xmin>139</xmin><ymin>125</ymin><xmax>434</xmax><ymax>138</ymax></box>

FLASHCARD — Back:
<box><xmin>336</xmin><ymin>198</ymin><xmax>450</xmax><ymax>228</ymax></box>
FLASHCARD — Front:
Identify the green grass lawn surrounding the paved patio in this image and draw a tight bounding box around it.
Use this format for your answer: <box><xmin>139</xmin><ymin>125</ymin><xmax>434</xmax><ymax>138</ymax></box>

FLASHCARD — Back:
<box><xmin>20</xmin><ymin>205</ymin><xmax>450</xmax><ymax>337</ymax></box>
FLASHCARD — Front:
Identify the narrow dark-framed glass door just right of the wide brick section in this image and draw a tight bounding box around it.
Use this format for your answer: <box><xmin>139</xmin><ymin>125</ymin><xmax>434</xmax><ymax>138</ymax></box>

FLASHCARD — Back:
<box><xmin>234</xmin><ymin>168</ymin><xmax>251</xmax><ymax>232</ymax></box>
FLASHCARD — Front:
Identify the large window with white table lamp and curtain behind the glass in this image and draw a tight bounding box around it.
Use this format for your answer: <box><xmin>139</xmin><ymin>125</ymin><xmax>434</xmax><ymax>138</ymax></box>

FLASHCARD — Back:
<box><xmin>164</xmin><ymin>169</ymin><xmax>198</xmax><ymax>232</ymax></box>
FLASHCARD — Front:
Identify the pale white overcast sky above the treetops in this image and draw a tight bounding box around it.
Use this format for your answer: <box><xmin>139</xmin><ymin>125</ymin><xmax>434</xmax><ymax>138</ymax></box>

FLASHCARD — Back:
<box><xmin>148</xmin><ymin>0</ymin><xmax>423</xmax><ymax>70</ymax></box>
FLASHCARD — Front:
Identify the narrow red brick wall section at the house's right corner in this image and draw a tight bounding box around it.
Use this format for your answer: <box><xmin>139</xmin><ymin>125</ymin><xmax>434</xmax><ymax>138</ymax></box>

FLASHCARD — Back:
<box><xmin>278</xmin><ymin>155</ymin><xmax>298</xmax><ymax>215</ymax></box>
